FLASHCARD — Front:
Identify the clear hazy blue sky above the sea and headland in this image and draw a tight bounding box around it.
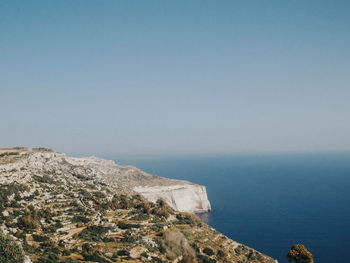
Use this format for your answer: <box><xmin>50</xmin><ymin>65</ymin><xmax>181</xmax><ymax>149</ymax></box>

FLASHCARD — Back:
<box><xmin>0</xmin><ymin>0</ymin><xmax>350</xmax><ymax>155</ymax></box>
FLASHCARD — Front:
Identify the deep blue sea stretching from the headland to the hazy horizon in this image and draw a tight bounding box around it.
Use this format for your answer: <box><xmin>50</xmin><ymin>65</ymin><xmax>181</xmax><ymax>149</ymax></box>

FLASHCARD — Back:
<box><xmin>113</xmin><ymin>153</ymin><xmax>350</xmax><ymax>263</ymax></box>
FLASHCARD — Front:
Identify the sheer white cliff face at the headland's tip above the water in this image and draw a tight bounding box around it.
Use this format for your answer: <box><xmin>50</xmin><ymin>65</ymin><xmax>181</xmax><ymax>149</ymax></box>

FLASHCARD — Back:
<box><xmin>133</xmin><ymin>184</ymin><xmax>210</xmax><ymax>213</ymax></box>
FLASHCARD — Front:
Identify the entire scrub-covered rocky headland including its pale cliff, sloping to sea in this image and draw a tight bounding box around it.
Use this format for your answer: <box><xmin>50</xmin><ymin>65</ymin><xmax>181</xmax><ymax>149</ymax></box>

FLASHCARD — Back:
<box><xmin>0</xmin><ymin>148</ymin><xmax>274</xmax><ymax>263</ymax></box>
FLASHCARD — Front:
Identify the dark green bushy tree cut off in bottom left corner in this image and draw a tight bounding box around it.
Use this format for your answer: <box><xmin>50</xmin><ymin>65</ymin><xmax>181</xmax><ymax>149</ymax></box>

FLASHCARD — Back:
<box><xmin>0</xmin><ymin>233</ymin><xmax>24</xmax><ymax>263</ymax></box>
